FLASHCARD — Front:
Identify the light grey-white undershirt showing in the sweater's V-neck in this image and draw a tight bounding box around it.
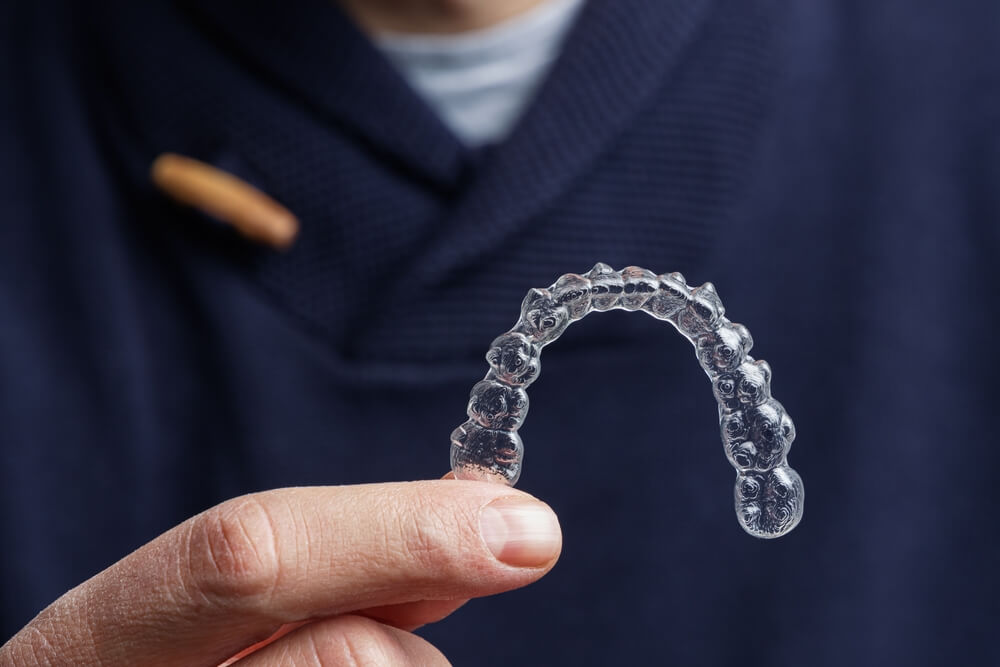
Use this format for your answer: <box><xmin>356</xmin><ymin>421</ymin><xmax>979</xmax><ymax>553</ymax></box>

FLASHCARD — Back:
<box><xmin>375</xmin><ymin>0</ymin><xmax>585</xmax><ymax>147</ymax></box>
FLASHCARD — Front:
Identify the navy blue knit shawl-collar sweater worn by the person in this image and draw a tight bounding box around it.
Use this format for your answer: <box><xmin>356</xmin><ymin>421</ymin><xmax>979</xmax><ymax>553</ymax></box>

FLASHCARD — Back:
<box><xmin>0</xmin><ymin>0</ymin><xmax>1000</xmax><ymax>666</ymax></box>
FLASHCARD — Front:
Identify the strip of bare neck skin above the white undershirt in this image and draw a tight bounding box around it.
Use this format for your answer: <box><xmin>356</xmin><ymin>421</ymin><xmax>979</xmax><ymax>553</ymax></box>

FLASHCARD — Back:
<box><xmin>338</xmin><ymin>0</ymin><xmax>545</xmax><ymax>35</ymax></box>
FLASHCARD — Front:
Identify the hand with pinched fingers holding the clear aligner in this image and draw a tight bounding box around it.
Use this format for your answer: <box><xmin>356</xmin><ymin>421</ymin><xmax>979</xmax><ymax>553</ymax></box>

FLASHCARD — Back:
<box><xmin>0</xmin><ymin>481</ymin><xmax>562</xmax><ymax>667</ymax></box>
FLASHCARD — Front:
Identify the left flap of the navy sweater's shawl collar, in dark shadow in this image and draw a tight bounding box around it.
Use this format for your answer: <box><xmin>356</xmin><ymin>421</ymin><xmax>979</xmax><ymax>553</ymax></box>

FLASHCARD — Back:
<box><xmin>177</xmin><ymin>0</ymin><xmax>469</xmax><ymax>187</ymax></box>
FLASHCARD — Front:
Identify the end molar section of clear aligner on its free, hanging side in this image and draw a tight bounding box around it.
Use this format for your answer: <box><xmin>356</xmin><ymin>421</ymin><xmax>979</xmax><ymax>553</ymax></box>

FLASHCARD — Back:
<box><xmin>734</xmin><ymin>465</ymin><xmax>805</xmax><ymax>539</ymax></box>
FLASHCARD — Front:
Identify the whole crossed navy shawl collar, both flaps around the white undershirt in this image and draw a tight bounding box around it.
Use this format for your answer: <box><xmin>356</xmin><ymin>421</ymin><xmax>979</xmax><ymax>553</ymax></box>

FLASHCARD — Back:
<box><xmin>177</xmin><ymin>0</ymin><xmax>714</xmax><ymax>282</ymax></box>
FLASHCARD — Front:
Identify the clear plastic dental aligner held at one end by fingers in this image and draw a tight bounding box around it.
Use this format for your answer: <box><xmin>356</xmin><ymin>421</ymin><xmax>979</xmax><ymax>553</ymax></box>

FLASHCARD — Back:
<box><xmin>451</xmin><ymin>263</ymin><xmax>804</xmax><ymax>538</ymax></box>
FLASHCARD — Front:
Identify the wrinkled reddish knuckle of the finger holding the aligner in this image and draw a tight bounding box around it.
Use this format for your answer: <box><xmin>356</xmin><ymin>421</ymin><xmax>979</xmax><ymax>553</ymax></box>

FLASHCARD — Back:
<box><xmin>187</xmin><ymin>495</ymin><xmax>281</xmax><ymax>604</ymax></box>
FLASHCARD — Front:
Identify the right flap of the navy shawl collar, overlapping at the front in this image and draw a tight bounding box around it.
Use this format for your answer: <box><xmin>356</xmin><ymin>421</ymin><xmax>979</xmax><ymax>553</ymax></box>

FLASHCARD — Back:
<box><xmin>407</xmin><ymin>0</ymin><xmax>712</xmax><ymax>287</ymax></box>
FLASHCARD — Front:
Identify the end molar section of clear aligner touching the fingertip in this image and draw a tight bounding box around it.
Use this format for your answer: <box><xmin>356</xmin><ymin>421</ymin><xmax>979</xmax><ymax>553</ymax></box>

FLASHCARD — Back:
<box><xmin>451</xmin><ymin>420</ymin><xmax>524</xmax><ymax>486</ymax></box>
